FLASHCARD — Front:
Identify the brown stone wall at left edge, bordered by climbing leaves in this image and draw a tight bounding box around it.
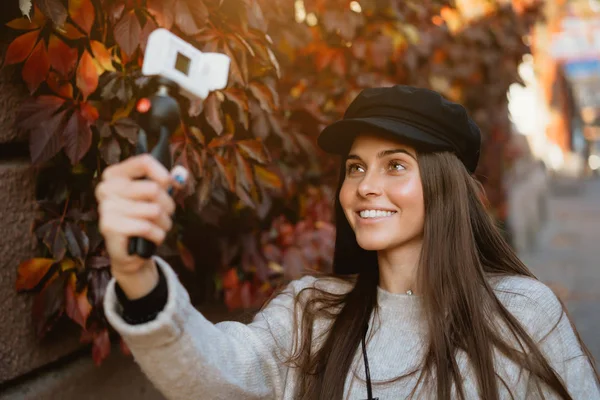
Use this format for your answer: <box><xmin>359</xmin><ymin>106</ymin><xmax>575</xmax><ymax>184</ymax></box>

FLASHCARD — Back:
<box><xmin>0</xmin><ymin>0</ymin><xmax>162</xmax><ymax>400</ymax></box>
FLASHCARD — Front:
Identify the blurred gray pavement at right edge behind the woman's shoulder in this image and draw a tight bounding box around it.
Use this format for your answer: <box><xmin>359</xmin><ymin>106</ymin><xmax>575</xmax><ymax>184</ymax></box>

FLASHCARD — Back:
<box><xmin>520</xmin><ymin>178</ymin><xmax>600</xmax><ymax>365</ymax></box>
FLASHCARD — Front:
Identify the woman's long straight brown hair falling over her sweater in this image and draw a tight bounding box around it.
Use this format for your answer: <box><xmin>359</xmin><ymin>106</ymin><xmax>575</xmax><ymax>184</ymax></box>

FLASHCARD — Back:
<box><xmin>278</xmin><ymin>148</ymin><xmax>598</xmax><ymax>400</ymax></box>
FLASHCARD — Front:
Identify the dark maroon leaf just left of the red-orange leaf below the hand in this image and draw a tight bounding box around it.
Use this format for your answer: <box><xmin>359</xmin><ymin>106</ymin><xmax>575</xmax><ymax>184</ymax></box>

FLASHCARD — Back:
<box><xmin>31</xmin><ymin>274</ymin><xmax>67</xmax><ymax>338</ymax></box>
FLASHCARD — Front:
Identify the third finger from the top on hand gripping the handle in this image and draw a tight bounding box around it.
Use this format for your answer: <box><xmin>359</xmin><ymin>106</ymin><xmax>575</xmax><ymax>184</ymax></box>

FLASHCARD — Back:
<box><xmin>101</xmin><ymin>198</ymin><xmax>173</xmax><ymax>232</ymax></box>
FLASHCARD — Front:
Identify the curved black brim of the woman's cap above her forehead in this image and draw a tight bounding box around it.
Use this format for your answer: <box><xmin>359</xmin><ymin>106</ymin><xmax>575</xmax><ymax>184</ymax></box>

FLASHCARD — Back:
<box><xmin>317</xmin><ymin>117</ymin><xmax>448</xmax><ymax>155</ymax></box>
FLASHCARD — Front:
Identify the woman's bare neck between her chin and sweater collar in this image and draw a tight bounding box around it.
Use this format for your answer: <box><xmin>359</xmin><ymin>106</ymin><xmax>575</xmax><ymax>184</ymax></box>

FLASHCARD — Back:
<box><xmin>377</xmin><ymin>239</ymin><xmax>423</xmax><ymax>294</ymax></box>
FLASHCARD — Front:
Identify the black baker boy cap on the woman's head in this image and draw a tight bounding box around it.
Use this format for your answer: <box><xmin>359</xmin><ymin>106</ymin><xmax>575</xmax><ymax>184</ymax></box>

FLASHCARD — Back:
<box><xmin>318</xmin><ymin>85</ymin><xmax>481</xmax><ymax>173</ymax></box>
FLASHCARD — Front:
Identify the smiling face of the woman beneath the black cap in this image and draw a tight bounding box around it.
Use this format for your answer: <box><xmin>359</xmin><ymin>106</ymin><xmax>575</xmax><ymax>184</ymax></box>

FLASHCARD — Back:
<box><xmin>340</xmin><ymin>135</ymin><xmax>425</xmax><ymax>251</ymax></box>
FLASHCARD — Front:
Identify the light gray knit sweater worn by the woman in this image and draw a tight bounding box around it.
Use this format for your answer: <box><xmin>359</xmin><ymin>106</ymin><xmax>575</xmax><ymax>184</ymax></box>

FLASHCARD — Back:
<box><xmin>104</xmin><ymin>257</ymin><xmax>600</xmax><ymax>400</ymax></box>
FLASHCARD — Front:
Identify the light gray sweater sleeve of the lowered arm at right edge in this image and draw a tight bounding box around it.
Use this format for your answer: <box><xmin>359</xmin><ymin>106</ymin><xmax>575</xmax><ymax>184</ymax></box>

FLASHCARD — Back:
<box><xmin>527</xmin><ymin>283</ymin><xmax>600</xmax><ymax>400</ymax></box>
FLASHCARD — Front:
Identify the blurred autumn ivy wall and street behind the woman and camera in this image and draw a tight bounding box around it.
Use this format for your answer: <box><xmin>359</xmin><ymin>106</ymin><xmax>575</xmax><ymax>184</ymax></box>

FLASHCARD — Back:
<box><xmin>0</xmin><ymin>0</ymin><xmax>600</xmax><ymax>400</ymax></box>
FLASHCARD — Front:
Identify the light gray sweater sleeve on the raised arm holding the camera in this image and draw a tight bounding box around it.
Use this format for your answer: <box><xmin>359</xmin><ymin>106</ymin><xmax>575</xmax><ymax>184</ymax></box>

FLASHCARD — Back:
<box><xmin>104</xmin><ymin>257</ymin><xmax>315</xmax><ymax>399</ymax></box>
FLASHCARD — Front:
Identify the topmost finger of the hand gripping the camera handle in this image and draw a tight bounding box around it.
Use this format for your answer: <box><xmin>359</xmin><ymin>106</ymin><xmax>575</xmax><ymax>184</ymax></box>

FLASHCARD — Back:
<box><xmin>102</xmin><ymin>154</ymin><xmax>171</xmax><ymax>189</ymax></box>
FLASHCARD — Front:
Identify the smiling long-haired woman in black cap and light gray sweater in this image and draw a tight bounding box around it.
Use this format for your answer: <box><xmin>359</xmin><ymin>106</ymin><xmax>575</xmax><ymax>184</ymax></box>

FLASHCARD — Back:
<box><xmin>97</xmin><ymin>86</ymin><xmax>600</xmax><ymax>400</ymax></box>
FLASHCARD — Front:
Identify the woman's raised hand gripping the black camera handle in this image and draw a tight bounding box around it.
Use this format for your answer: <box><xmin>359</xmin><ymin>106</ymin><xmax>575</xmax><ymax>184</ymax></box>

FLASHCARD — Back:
<box><xmin>96</xmin><ymin>154</ymin><xmax>187</xmax><ymax>298</ymax></box>
